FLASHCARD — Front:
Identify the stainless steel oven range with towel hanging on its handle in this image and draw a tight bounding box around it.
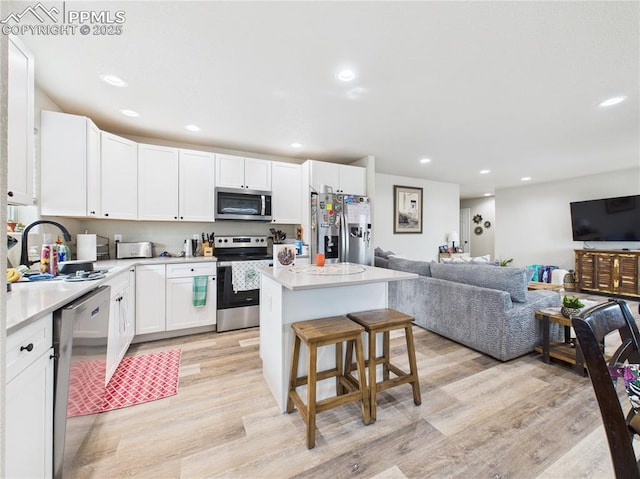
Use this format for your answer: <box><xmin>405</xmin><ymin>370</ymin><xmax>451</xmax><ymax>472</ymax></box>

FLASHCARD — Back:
<box><xmin>214</xmin><ymin>236</ymin><xmax>273</xmax><ymax>332</ymax></box>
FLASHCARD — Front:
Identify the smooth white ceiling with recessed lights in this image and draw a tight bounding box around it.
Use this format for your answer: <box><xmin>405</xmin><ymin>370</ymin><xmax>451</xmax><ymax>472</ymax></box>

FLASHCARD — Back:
<box><xmin>12</xmin><ymin>1</ymin><xmax>640</xmax><ymax>198</ymax></box>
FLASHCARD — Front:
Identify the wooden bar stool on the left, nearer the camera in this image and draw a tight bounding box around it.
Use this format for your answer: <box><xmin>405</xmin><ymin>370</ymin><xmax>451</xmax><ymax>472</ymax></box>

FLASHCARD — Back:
<box><xmin>287</xmin><ymin>316</ymin><xmax>371</xmax><ymax>449</ymax></box>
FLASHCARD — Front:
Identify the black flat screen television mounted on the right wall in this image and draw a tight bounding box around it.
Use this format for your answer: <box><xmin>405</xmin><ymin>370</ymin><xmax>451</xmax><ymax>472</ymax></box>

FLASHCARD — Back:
<box><xmin>570</xmin><ymin>195</ymin><xmax>640</xmax><ymax>241</ymax></box>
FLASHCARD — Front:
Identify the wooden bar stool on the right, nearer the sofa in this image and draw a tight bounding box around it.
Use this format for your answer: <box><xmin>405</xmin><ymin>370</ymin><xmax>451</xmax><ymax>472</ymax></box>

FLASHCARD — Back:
<box><xmin>345</xmin><ymin>309</ymin><xmax>422</xmax><ymax>421</ymax></box>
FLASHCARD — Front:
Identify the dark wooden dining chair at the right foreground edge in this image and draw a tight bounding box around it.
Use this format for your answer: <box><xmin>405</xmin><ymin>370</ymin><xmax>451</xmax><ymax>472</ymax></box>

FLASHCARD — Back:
<box><xmin>571</xmin><ymin>299</ymin><xmax>640</xmax><ymax>479</ymax></box>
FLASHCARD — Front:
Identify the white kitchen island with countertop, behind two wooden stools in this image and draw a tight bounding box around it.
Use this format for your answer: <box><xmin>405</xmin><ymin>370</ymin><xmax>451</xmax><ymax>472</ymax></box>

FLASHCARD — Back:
<box><xmin>260</xmin><ymin>263</ymin><xmax>418</xmax><ymax>412</ymax></box>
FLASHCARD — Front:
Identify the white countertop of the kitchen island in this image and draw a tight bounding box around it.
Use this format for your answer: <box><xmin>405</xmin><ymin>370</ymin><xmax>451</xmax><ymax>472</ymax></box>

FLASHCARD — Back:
<box><xmin>260</xmin><ymin>263</ymin><xmax>418</xmax><ymax>291</ymax></box>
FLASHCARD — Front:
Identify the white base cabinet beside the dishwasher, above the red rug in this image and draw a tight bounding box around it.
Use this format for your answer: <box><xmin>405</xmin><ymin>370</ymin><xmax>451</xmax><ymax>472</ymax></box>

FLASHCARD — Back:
<box><xmin>105</xmin><ymin>271</ymin><xmax>135</xmax><ymax>385</ymax></box>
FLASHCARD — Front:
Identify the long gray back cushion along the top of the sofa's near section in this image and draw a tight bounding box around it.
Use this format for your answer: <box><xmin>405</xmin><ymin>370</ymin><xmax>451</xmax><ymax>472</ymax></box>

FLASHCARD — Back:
<box><xmin>431</xmin><ymin>263</ymin><xmax>529</xmax><ymax>303</ymax></box>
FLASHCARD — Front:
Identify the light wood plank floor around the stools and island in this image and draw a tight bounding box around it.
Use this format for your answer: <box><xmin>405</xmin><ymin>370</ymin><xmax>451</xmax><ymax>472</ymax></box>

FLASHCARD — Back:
<box><xmin>67</xmin><ymin>303</ymin><xmax>637</xmax><ymax>479</ymax></box>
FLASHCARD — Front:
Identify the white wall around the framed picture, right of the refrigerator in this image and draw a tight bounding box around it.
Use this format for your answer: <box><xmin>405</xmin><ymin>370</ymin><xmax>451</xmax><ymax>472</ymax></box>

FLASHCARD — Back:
<box><xmin>373</xmin><ymin>173</ymin><xmax>460</xmax><ymax>260</ymax></box>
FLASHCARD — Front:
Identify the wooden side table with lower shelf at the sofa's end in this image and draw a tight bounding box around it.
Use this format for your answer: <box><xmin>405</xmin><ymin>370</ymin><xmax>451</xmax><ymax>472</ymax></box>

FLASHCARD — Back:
<box><xmin>535</xmin><ymin>308</ymin><xmax>585</xmax><ymax>375</ymax></box>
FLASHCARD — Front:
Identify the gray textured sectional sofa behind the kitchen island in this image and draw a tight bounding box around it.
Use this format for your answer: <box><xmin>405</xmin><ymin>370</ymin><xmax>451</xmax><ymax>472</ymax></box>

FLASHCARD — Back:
<box><xmin>387</xmin><ymin>256</ymin><xmax>560</xmax><ymax>361</ymax></box>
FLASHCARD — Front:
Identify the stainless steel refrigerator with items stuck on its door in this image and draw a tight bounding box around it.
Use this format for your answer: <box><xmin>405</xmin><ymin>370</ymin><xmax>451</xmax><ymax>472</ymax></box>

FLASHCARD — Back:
<box><xmin>311</xmin><ymin>191</ymin><xmax>373</xmax><ymax>265</ymax></box>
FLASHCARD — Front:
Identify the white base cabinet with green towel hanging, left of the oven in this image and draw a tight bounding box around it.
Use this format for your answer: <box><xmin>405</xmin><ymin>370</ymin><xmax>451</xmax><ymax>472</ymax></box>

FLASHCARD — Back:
<box><xmin>166</xmin><ymin>262</ymin><xmax>217</xmax><ymax>331</ymax></box>
